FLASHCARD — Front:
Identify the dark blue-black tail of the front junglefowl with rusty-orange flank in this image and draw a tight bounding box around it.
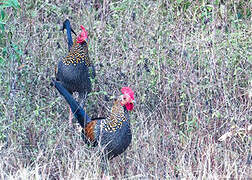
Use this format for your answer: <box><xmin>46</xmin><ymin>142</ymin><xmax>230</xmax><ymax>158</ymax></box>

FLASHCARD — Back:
<box><xmin>51</xmin><ymin>80</ymin><xmax>91</xmax><ymax>128</ymax></box>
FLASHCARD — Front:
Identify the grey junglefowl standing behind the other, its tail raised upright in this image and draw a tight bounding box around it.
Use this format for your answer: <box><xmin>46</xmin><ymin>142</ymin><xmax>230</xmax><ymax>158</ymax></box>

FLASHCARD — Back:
<box><xmin>56</xmin><ymin>21</ymin><xmax>95</xmax><ymax>125</ymax></box>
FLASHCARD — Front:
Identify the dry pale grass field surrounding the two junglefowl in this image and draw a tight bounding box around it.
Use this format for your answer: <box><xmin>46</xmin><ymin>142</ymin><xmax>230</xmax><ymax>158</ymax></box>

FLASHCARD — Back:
<box><xmin>0</xmin><ymin>0</ymin><xmax>252</xmax><ymax>179</ymax></box>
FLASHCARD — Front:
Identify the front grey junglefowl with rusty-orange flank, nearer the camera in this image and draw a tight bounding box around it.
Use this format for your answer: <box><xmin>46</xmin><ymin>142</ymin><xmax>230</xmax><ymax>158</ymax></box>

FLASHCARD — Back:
<box><xmin>51</xmin><ymin>80</ymin><xmax>134</xmax><ymax>178</ymax></box>
